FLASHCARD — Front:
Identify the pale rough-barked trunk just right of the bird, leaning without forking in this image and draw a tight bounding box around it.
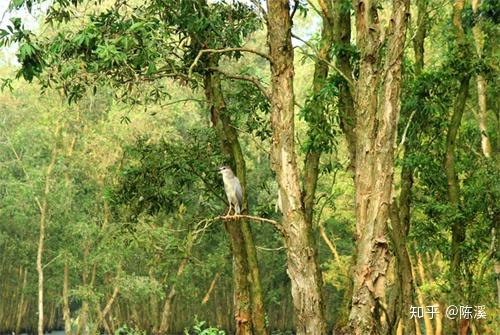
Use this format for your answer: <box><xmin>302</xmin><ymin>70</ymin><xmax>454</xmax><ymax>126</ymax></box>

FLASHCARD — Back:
<box><xmin>267</xmin><ymin>0</ymin><xmax>326</xmax><ymax>335</ymax></box>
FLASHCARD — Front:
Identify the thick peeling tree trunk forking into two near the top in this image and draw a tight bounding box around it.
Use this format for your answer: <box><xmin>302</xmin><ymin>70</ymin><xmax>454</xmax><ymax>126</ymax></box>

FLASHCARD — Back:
<box><xmin>350</xmin><ymin>0</ymin><xmax>409</xmax><ymax>335</ymax></box>
